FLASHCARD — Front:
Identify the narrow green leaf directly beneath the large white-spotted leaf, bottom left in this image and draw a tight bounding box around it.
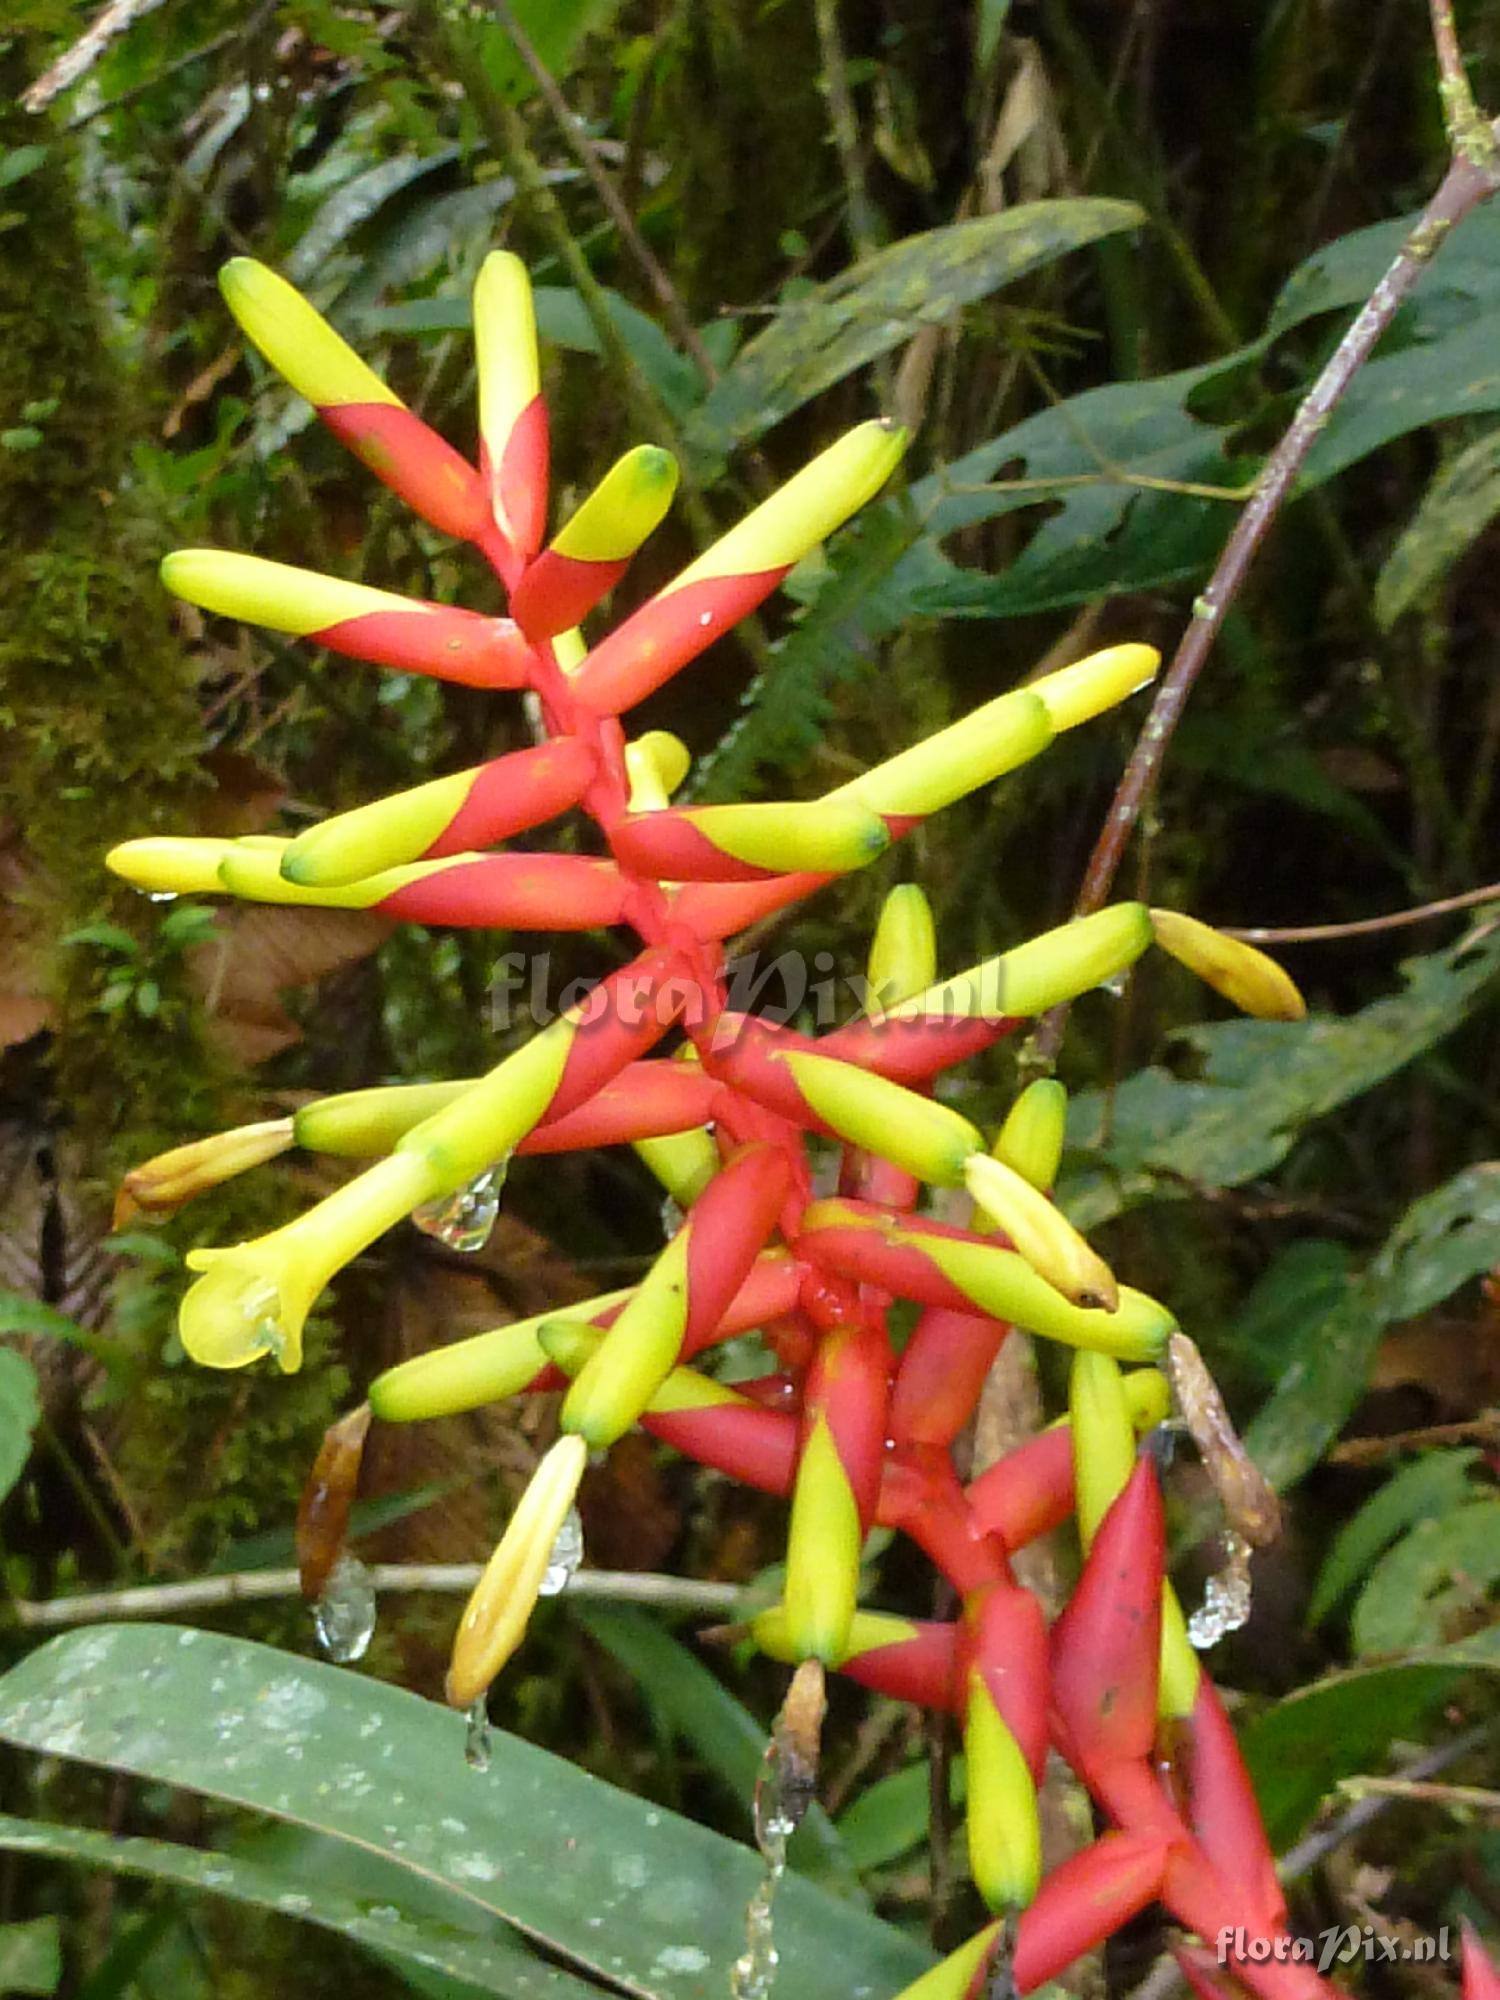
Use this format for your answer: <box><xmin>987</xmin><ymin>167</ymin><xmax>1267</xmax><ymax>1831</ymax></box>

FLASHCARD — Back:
<box><xmin>0</xmin><ymin>1818</ymin><xmax>598</xmax><ymax>2000</ymax></box>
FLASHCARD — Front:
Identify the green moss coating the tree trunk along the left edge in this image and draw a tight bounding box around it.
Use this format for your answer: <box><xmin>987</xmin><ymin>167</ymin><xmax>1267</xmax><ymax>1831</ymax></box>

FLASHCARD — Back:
<box><xmin>0</xmin><ymin>36</ymin><xmax>344</xmax><ymax>1558</ymax></box>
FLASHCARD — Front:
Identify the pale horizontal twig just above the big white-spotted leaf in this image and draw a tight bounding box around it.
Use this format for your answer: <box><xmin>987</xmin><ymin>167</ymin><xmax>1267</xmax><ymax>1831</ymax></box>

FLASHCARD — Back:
<box><xmin>10</xmin><ymin>1562</ymin><xmax>754</xmax><ymax>1630</ymax></box>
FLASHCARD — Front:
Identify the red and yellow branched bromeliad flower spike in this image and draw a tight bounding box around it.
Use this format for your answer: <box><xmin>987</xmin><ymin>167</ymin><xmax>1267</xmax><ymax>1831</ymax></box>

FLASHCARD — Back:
<box><xmin>110</xmin><ymin>254</ymin><xmax>1368</xmax><ymax>2000</ymax></box>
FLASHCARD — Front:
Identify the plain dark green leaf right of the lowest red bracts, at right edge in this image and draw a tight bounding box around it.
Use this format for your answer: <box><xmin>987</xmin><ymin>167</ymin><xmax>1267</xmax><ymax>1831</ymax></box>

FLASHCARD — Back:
<box><xmin>1240</xmin><ymin>1626</ymin><xmax>1500</xmax><ymax>1848</ymax></box>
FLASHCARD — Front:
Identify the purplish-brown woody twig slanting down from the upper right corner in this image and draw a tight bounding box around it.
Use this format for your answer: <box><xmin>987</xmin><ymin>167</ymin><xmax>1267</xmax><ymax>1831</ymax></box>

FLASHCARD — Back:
<box><xmin>1032</xmin><ymin>126</ymin><xmax>1500</xmax><ymax>1066</ymax></box>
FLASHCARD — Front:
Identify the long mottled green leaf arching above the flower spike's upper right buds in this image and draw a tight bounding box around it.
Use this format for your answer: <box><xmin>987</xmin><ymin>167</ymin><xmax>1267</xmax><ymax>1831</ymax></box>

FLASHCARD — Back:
<box><xmin>686</xmin><ymin>200</ymin><xmax>1144</xmax><ymax>466</ymax></box>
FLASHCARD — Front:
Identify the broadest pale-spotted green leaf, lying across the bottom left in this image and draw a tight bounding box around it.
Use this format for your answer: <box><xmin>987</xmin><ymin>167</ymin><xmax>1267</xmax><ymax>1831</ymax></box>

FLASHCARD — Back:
<box><xmin>0</xmin><ymin>1626</ymin><xmax>932</xmax><ymax>2000</ymax></box>
